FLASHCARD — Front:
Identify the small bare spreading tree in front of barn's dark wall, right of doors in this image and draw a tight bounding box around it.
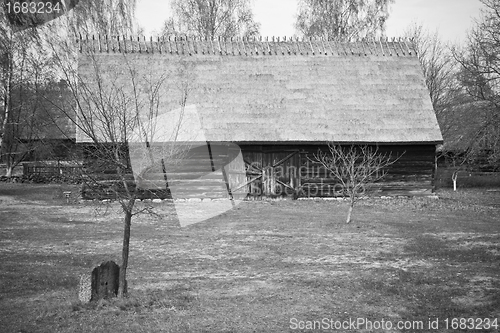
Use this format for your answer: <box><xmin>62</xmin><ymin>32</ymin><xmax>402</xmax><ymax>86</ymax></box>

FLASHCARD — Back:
<box><xmin>310</xmin><ymin>143</ymin><xmax>401</xmax><ymax>223</ymax></box>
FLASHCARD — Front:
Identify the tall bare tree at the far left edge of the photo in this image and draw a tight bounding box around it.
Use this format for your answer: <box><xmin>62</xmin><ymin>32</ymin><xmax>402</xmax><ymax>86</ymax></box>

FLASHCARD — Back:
<box><xmin>0</xmin><ymin>6</ymin><xmax>50</xmax><ymax>177</ymax></box>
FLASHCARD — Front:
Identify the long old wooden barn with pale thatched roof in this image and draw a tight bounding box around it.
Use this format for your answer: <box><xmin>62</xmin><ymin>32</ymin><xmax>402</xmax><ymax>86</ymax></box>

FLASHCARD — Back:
<box><xmin>77</xmin><ymin>38</ymin><xmax>442</xmax><ymax>197</ymax></box>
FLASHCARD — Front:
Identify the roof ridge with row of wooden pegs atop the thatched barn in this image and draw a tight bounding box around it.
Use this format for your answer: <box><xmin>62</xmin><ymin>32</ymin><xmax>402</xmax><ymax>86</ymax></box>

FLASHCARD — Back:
<box><xmin>76</xmin><ymin>35</ymin><xmax>416</xmax><ymax>56</ymax></box>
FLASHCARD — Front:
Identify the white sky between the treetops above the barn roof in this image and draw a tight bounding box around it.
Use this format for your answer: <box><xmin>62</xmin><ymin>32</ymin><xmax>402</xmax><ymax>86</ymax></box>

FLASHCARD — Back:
<box><xmin>137</xmin><ymin>0</ymin><xmax>482</xmax><ymax>42</ymax></box>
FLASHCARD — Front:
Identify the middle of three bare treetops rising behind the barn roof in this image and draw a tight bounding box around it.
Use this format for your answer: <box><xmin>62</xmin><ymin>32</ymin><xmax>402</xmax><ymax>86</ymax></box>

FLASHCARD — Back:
<box><xmin>166</xmin><ymin>0</ymin><xmax>259</xmax><ymax>39</ymax></box>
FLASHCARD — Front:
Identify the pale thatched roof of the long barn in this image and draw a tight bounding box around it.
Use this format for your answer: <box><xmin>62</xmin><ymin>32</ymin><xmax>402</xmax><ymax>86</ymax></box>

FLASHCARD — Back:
<box><xmin>78</xmin><ymin>39</ymin><xmax>442</xmax><ymax>143</ymax></box>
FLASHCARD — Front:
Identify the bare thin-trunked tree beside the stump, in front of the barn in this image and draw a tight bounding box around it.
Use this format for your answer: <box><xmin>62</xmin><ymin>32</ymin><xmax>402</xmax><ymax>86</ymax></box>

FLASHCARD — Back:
<box><xmin>44</xmin><ymin>37</ymin><xmax>191</xmax><ymax>297</ymax></box>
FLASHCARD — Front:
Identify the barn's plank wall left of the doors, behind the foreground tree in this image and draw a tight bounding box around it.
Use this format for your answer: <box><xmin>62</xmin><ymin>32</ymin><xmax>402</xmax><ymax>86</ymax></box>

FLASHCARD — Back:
<box><xmin>83</xmin><ymin>141</ymin><xmax>236</xmax><ymax>199</ymax></box>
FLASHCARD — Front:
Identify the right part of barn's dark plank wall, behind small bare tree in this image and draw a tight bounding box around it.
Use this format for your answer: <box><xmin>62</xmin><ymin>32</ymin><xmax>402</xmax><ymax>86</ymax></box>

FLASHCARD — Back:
<box><xmin>241</xmin><ymin>145</ymin><xmax>435</xmax><ymax>197</ymax></box>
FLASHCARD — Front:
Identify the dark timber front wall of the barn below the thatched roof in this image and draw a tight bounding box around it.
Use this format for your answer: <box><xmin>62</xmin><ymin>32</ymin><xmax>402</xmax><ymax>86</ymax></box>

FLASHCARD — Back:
<box><xmin>80</xmin><ymin>143</ymin><xmax>435</xmax><ymax>198</ymax></box>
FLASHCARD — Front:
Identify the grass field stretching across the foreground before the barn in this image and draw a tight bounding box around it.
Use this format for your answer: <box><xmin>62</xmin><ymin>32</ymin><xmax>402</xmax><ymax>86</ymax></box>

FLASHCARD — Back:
<box><xmin>0</xmin><ymin>183</ymin><xmax>500</xmax><ymax>333</ymax></box>
